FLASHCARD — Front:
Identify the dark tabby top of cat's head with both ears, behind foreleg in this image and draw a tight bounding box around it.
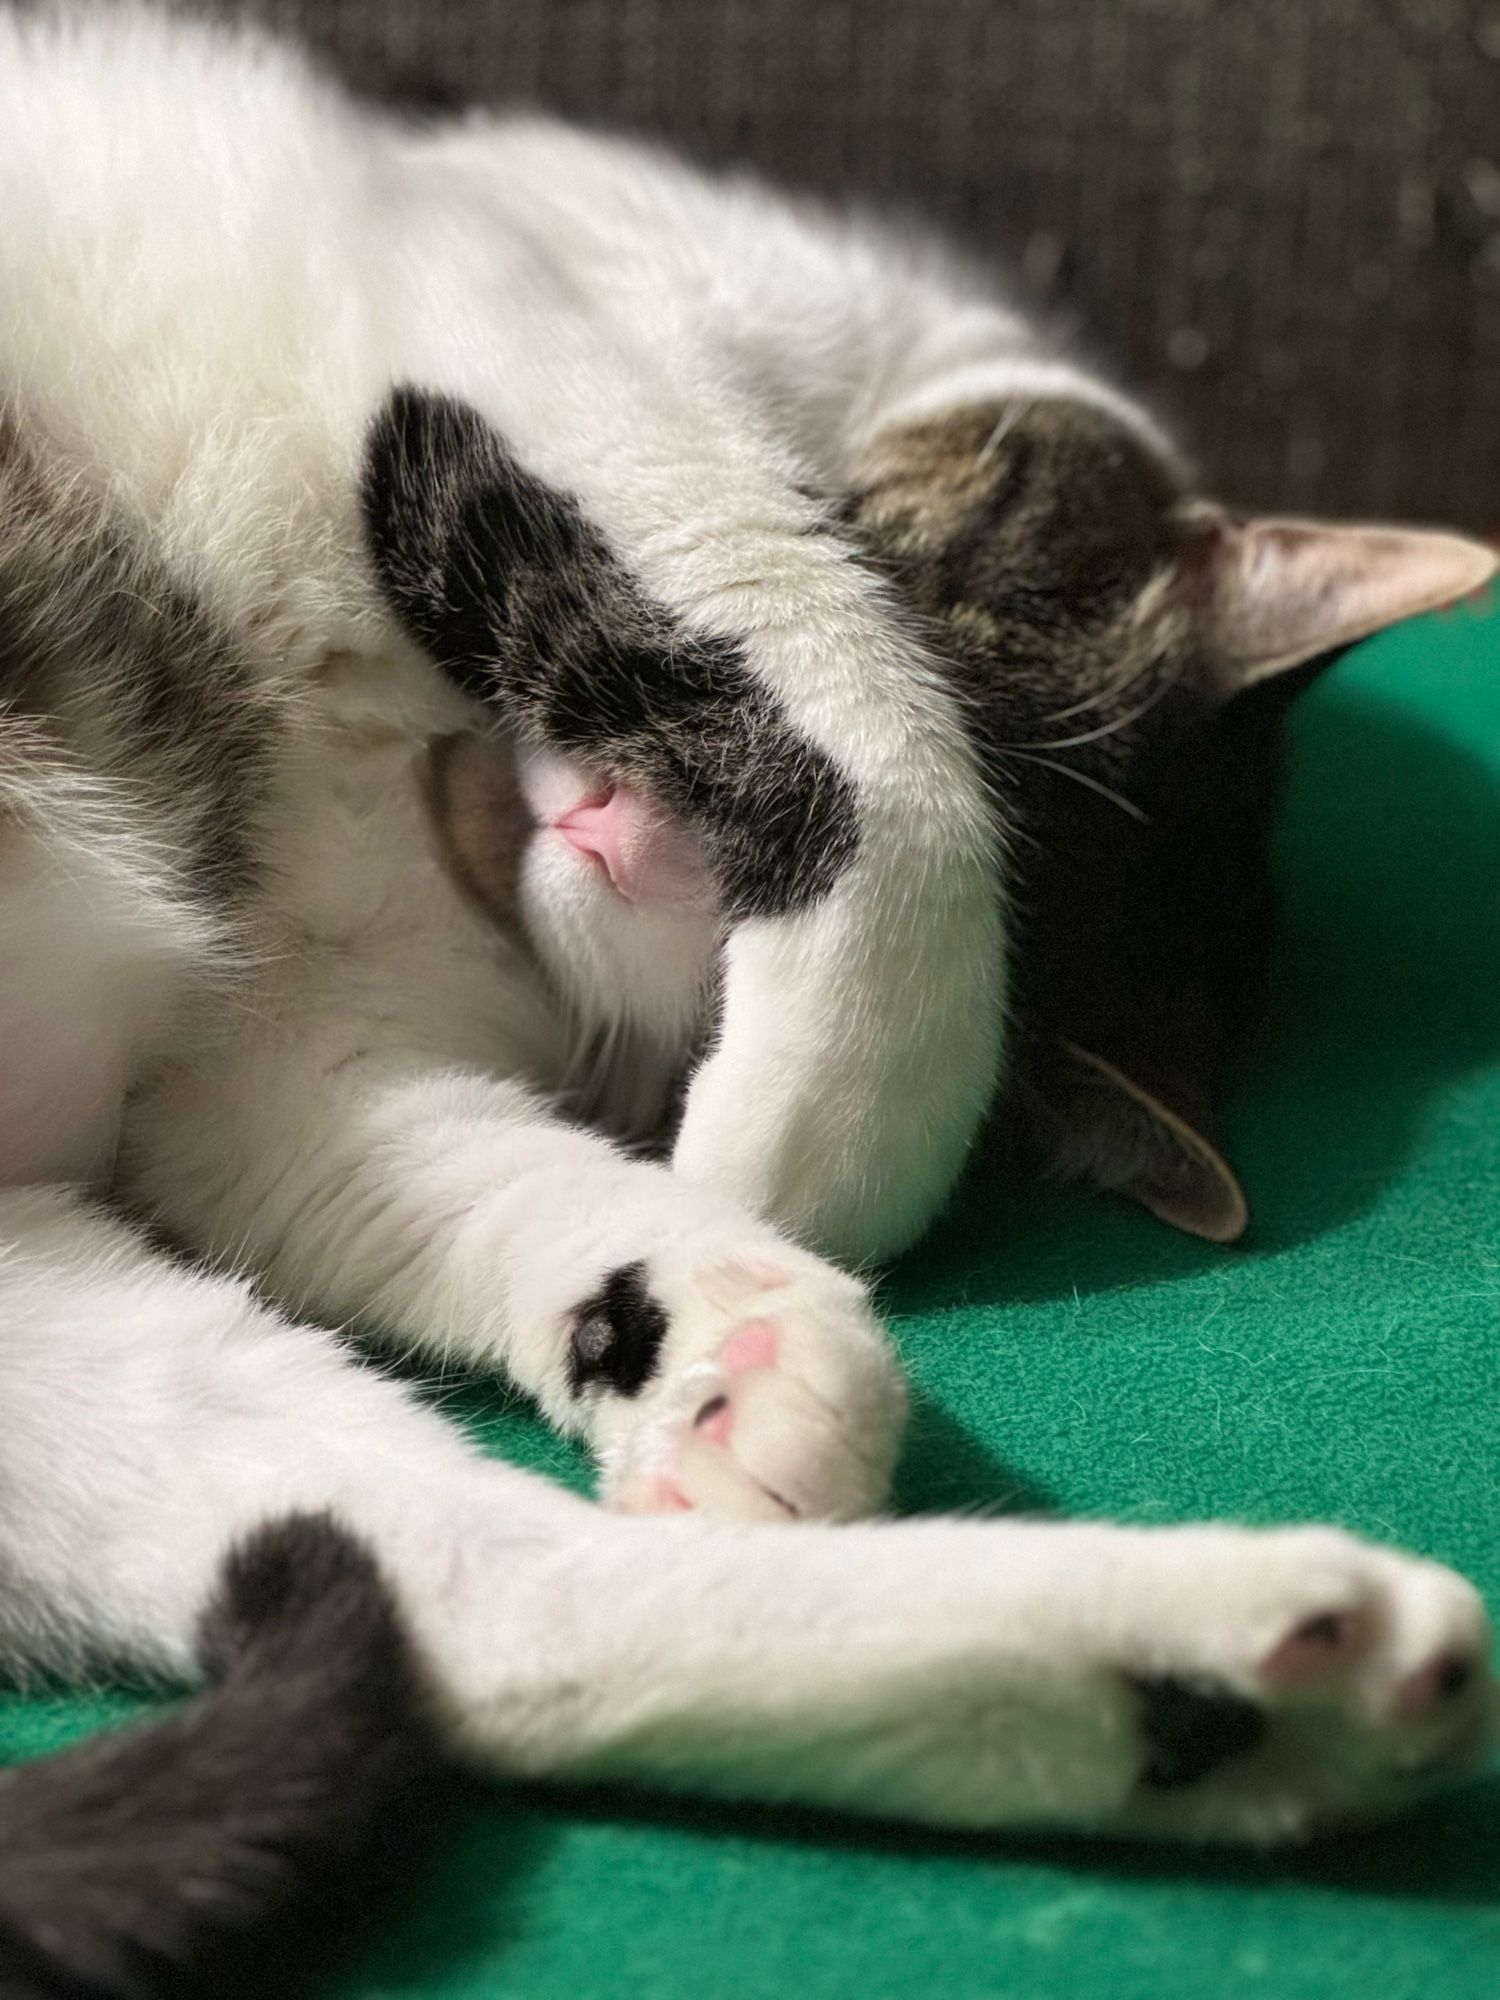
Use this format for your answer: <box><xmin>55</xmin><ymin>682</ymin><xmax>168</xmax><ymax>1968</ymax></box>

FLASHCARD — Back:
<box><xmin>844</xmin><ymin>400</ymin><xmax>1496</xmax><ymax>1242</ymax></box>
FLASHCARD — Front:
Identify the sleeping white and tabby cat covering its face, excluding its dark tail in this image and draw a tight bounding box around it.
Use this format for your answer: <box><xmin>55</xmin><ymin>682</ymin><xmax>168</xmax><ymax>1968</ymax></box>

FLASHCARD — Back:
<box><xmin>0</xmin><ymin>10</ymin><xmax>1494</xmax><ymax>1992</ymax></box>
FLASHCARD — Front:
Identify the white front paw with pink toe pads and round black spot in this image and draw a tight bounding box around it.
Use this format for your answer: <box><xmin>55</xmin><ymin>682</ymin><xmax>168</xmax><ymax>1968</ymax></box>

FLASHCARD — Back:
<box><xmin>570</xmin><ymin>1238</ymin><xmax>906</xmax><ymax>1520</ymax></box>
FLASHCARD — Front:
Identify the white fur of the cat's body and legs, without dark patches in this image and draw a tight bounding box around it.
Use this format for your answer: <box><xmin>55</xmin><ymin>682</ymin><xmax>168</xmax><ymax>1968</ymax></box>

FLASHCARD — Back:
<box><xmin>0</xmin><ymin>8</ymin><xmax>1486</xmax><ymax>1838</ymax></box>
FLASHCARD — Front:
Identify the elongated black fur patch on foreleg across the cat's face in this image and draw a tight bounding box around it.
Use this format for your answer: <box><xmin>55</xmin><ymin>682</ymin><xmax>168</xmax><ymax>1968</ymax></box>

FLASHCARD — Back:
<box><xmin>362</xmin><ymin>388</ymin><xmax>858</xmax><ymax>918</ymax></box>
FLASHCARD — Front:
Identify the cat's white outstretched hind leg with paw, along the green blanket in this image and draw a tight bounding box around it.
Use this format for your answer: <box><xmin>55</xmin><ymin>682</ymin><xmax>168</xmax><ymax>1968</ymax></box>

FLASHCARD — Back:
<box><xmin>0</xmin><ymin>1190</ymin><xmax>1492</xmax><ymax>1842</ymax></box>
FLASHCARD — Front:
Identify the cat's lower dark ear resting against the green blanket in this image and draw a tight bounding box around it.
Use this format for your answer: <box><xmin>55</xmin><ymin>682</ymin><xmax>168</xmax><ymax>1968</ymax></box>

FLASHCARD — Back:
<box><xmin>1012</xmin><ymin>1038</ymin><xmax>1250</xmax><ymax>1244</ymax></box>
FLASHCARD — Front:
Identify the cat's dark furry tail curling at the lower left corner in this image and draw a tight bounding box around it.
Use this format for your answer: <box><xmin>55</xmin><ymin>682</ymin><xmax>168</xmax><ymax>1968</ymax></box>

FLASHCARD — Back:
<box><xmin>0</xmin><ymin>1516</ymin><xmax>438</xmax><ymax>2000</ymax></box>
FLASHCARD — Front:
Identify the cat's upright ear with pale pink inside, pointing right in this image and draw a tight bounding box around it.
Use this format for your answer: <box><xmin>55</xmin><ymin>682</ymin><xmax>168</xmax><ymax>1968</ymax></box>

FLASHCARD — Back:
<box><xmin>1182</xmin><ymin>506</ymin><xmax>1500</xmax><ymax>694</ymax></box>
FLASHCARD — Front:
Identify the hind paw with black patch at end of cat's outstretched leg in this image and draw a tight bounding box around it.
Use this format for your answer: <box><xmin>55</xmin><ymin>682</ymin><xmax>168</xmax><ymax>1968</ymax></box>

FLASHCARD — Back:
<box><xmin>1128</xmin><ymin>1528</ymin><xmax>1496</xmax><ymax>1840</ymax></box>
